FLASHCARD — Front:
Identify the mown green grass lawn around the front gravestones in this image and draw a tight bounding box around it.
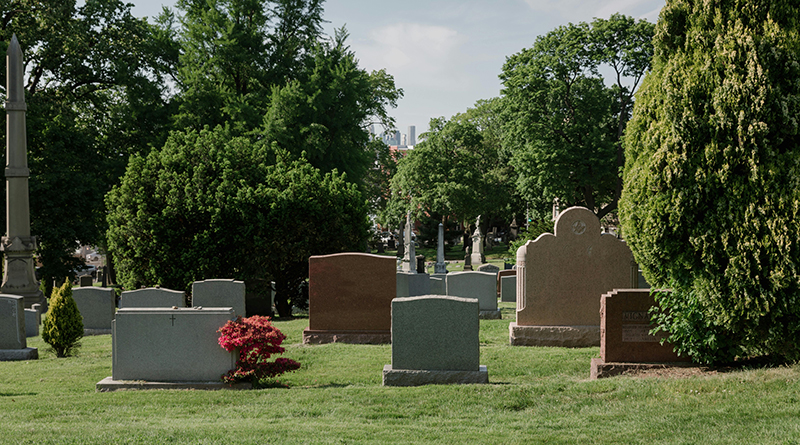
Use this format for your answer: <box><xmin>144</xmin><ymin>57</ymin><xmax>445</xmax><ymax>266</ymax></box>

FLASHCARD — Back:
<box><xmin>0</xmin><ymin>303</ymin><xmax>800</xmax><ymax>445</ymax></box>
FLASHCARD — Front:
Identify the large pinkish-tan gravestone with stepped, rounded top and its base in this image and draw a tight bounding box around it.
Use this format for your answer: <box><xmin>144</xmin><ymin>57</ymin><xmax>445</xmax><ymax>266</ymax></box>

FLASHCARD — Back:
<box><xmin>509</xmin><ymin>207</ymin><xmax>638</xmax><ymax>347</ymax></box>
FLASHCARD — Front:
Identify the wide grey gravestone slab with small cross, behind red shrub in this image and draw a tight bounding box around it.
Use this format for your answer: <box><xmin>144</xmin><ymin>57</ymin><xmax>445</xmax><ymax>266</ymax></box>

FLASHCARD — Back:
<box><xmin>105</xmin><ymin>308</ymin><xmax>238</xmax><ymax>382</ymax></box>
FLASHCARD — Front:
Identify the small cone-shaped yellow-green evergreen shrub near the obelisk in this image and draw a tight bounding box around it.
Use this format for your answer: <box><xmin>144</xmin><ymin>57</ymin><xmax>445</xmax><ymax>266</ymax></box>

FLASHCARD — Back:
<box><xmin>42</xmin><ymin>280</ymin><xmax>83</xmax><ymax>357</ymax></box>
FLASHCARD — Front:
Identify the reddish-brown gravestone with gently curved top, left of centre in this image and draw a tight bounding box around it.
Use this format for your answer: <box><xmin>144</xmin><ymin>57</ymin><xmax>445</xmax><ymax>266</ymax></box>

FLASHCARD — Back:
<box><xmin>303</xmin><ymin>253</ymin><xmax>398</xmax><ymax>344</ymax></box>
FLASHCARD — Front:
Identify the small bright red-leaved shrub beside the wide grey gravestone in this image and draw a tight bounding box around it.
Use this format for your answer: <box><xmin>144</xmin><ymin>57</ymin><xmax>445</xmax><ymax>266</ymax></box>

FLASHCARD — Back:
<box><xmin>218</xmin><ymin>315</ymin><xmax>300</xmax><ymax>383</ymax></box>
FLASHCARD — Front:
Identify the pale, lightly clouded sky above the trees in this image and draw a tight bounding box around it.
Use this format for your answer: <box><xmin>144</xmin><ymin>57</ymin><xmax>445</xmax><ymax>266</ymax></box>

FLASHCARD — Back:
<box><xmin>133</xmin><ymin>0</ymin><xmax>666</xmax><ymax>136</ymax></box>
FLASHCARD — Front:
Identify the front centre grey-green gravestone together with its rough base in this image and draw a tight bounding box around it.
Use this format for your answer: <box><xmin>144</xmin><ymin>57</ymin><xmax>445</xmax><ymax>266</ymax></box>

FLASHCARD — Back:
<box><xmin>383</xmin><ymin>295</ymin><xmax>489</xmax><ymax>386</ymax></box>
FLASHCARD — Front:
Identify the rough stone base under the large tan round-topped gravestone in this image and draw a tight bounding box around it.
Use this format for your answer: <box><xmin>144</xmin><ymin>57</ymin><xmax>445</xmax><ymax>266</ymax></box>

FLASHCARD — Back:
<box><xmin>508</xmin><ymin>322</ymin><xmax>600</xmax><ymax>348</ymax></box>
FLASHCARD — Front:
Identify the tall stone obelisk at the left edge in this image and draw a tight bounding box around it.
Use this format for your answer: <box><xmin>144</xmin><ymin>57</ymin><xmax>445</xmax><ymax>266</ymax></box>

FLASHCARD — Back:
<box><xmin>0</xmin><ymin>35</ymin><xmax>47</xmax><ymax>308</ymax></box>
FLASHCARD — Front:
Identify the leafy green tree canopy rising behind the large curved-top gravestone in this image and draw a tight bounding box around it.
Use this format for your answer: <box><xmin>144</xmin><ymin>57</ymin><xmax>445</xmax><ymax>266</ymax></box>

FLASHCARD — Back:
<box><xmin>500</xmin><ymin>14</ymin><xmax>653</xmax><ymax>221</ymax></box>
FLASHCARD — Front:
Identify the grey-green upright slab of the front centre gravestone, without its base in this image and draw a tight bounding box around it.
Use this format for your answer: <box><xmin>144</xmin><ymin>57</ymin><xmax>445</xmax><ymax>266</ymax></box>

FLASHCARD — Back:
<box><xmin>392</xmin><ymin>295</ymin><xmax>480</xmax><ymax>371</ymax></box>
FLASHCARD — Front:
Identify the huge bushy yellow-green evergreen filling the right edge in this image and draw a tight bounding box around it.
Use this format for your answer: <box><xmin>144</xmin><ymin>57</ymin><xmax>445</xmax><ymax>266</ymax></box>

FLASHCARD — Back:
<box><xmin>620</xmin><ymin>0</ymin><xmax>800</xmax><ymax>362</ymax></box>
